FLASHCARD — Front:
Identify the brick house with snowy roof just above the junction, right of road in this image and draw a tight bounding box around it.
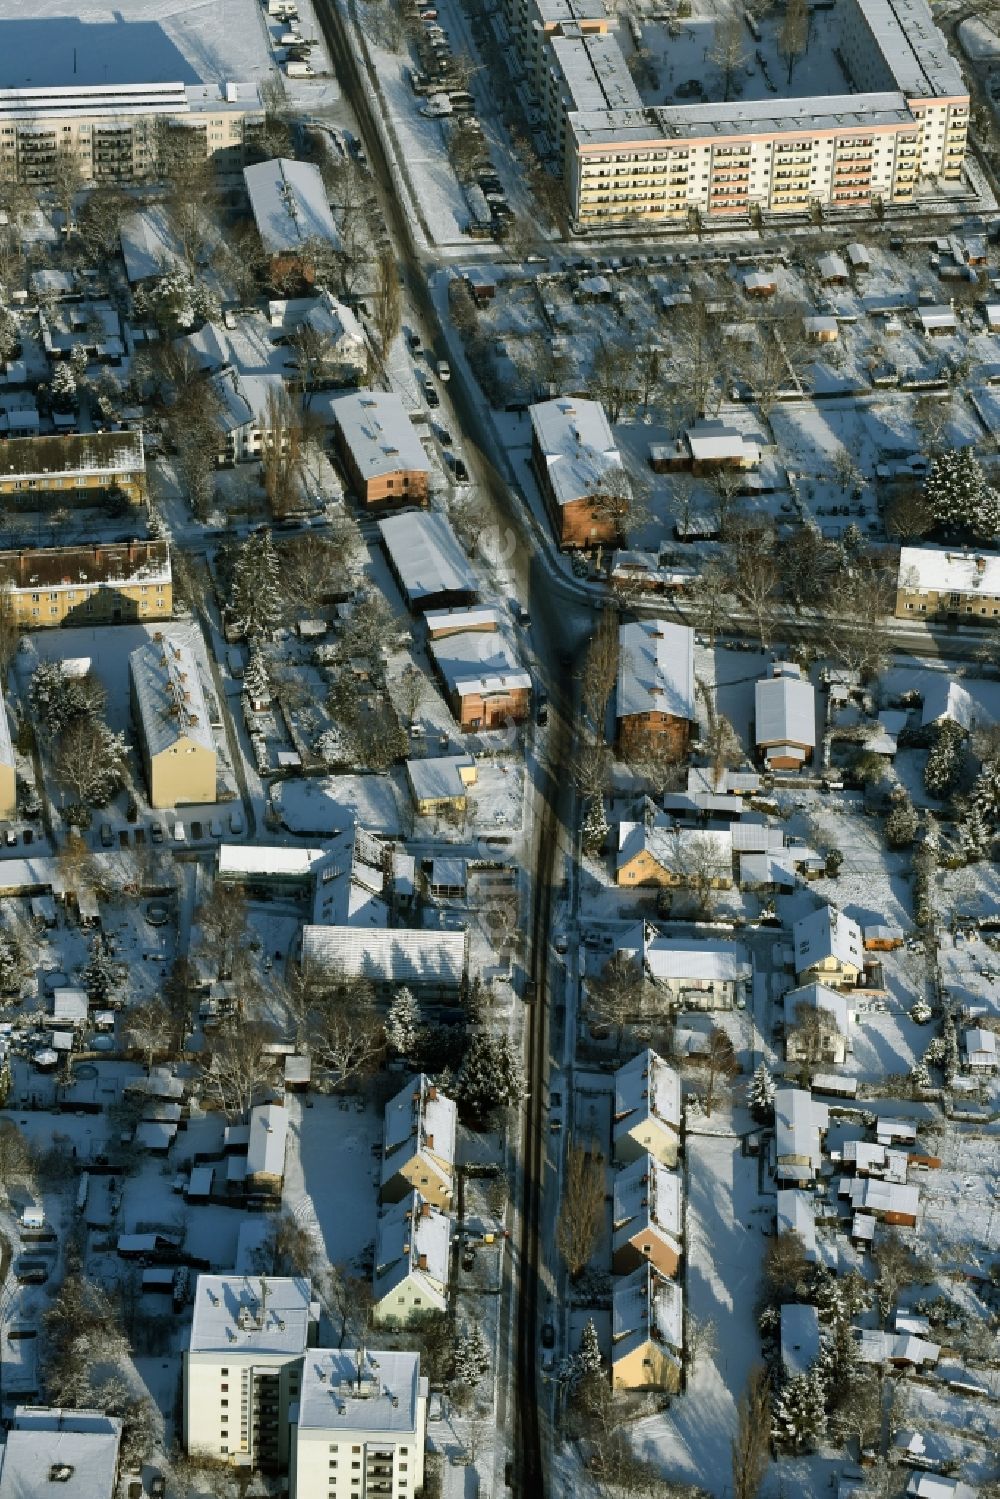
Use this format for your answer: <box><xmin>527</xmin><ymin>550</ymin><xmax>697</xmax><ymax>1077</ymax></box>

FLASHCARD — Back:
<box><xmin>529</xmin><ymin>397</ymin><xmax>630</xmax><ymax>547</ymax></box>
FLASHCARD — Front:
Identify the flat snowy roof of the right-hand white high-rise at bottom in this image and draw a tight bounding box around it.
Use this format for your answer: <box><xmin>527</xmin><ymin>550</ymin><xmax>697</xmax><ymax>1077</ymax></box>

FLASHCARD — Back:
<box><xmin>298</xmin><ymin>1348</ymin><xmax>427</xmax><ymax>1442</ymax></box>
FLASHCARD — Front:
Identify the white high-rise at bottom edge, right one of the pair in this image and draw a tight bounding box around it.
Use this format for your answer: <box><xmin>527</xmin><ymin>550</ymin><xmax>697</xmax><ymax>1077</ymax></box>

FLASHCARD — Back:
<box><xmin>289</xmin><ymin>1348</ymin><xmax>427</xmax><ymax>1499</ymax></box>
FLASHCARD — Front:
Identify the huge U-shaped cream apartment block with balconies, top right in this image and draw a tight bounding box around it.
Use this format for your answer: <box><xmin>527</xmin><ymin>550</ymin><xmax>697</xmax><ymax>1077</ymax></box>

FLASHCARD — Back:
<box><xmin>505</xmin><ymin>0</ymin><xmax>969</xmax><ymax>229</ymax></box>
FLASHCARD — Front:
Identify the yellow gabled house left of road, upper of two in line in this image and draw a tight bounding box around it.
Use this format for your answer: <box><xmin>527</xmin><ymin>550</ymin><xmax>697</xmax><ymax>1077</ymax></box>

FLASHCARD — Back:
<box><xmin>381</xmin><ymin>1073</ymin><xmax>457</xmax><ymax>1213</ymax></box>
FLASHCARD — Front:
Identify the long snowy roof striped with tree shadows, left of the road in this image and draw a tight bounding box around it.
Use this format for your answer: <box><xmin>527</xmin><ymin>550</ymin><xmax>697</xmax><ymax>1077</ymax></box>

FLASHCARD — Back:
<box><xmin>301</xmin><ymin>926</ymin><xmax>465</xmax><ymax>988</ymax></box>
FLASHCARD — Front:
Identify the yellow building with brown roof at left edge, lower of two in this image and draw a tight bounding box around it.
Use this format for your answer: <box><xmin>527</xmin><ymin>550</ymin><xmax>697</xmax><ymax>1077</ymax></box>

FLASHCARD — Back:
<box><xmin>0</xmin><ymin>541</ymin><xmax>174</xmax><ymax>630</ymax></box>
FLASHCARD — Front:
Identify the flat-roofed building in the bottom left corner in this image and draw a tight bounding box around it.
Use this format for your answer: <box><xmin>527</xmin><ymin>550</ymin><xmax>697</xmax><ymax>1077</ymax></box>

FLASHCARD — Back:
<box><xmin>0</xmin><ymin>1406</ymin><xmax>121</xmax><ymax>1499</ymax></box>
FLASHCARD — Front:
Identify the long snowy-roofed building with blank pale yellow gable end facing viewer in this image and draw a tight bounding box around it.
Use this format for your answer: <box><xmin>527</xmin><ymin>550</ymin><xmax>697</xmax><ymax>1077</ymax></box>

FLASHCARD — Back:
<box><xmin>129</xmin><ymin>634</ymin><xmax>216</xmax><ymax>806</ymax></box>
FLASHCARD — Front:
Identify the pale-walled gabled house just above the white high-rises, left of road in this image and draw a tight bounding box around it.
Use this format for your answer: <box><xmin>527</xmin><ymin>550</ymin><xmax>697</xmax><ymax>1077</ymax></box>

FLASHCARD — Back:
<box><xmin>372</xmin><ymin>1192</ymin><xmax>451</xmax><ymax>1327</ymax></box>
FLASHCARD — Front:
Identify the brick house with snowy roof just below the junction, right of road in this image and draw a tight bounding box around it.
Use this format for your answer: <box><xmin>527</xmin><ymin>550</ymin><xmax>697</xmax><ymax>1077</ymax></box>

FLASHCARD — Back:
<box><xmin>616</xmin><ymin>619</ymin><xmax>696</xmax><ymax>758</ymax></box>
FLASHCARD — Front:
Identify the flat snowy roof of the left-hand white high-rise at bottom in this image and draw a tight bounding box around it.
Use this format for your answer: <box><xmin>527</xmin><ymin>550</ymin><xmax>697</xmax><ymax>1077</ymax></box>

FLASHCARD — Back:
<box><xmin>187</xmin><ymin>1276</ymin><xmax>315</xmax><ymax>1358</ymax></box>
